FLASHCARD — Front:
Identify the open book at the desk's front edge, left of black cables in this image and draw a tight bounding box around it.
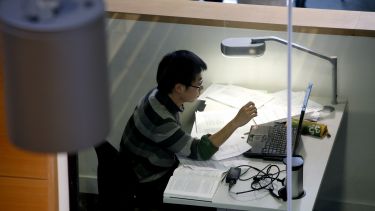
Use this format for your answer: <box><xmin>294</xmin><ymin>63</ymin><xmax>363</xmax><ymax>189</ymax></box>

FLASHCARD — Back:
<box><xmin>164</xmin><ymin>165</ymin><xmax>224</xmax><ymax>201</ymax></box>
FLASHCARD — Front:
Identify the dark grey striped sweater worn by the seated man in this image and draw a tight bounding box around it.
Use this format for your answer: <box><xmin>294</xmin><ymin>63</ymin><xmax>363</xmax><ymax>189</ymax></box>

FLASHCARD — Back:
<box><xmin>120</xmin><ymin>89</ymin><xmax>218</xmax><ymax>182</ymax></box>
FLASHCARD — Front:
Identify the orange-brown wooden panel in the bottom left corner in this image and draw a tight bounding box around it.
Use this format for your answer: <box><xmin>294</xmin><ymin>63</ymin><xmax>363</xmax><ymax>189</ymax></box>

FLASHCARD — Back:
<box><xmin>0</xmin><ymin>177</ymin><xmax>50</xmax><ymax>211</ymax></box>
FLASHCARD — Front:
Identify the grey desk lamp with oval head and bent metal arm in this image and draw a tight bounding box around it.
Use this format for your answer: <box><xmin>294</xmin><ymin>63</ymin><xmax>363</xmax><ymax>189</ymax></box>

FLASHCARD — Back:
<box><xmin>221</xmin><ymin>36</ymin><xmax>337</xmax><ymax>111</ymax></box>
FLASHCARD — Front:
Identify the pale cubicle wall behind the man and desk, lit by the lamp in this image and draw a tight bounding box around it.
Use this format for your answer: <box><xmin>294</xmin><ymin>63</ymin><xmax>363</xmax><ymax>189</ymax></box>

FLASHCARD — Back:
<box><xmin>79</xmin><ymin>19</ymin><xmax>375</xmax><ymax>210</ymax></box>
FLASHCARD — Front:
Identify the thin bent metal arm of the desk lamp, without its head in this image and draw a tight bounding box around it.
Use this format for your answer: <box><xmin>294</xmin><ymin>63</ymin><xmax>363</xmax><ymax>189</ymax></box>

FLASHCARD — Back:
<box><xmin>252</xmin><ymin>36</ymin><xmax>337</xmax><ymax>105</ymax></box>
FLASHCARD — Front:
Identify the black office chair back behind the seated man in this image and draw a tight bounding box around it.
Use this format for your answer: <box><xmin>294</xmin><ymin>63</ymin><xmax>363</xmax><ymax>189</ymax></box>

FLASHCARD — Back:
<box><xmin>95</xmin><ymin>141</ymin><xmax>138</xmax><ymax>211</ymax></box>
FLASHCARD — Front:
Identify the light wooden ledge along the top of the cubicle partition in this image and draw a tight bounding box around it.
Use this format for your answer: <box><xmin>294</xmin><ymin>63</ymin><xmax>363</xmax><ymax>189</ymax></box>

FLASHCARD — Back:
<box><xmin>105</xmin><ymin>0</ymin><xmax>375</xmax><ymax>36</ymax></box>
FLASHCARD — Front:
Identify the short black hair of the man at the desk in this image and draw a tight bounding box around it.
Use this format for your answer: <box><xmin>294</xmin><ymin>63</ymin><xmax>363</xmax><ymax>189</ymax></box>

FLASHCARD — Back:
<box><xmin>156</xmin><ymin>50</ymin><xmax>207</xmax><ymax>93</ymax></box>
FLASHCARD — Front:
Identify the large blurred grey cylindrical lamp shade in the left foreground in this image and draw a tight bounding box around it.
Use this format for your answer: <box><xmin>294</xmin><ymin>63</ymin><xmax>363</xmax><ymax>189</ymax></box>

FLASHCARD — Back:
<box><xmin>0</xmin><ymin>0</ymin><xmax>110</xmax><ymax>152</ymax></box>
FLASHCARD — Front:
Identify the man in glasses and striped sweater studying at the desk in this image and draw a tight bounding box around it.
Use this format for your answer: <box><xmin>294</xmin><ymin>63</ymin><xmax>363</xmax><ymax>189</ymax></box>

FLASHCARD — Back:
<box><xmin>120</xmin><ymin>50</ymin><xmax>257</xmax><ymax>208</ymax></box>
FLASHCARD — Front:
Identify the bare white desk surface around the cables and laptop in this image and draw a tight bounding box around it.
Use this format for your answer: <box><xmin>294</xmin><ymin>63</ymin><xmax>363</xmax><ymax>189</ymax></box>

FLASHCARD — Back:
<box><xmin>164</xmin><ymin>101</ymin><xmax>346</xmax><ymax>211</ymax></box>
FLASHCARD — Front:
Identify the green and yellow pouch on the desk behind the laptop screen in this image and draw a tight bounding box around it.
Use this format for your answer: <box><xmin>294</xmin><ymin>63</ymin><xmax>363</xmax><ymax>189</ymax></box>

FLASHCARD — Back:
<box><xmin>292</xmin><ymin>119</ymin><xmax>330</xmax><ymax>138</ymax></box>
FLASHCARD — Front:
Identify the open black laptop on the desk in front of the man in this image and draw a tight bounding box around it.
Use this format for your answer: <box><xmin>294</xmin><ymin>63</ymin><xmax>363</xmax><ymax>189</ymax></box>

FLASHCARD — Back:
<box><xmin>243</xmin><ymin>83</ymin><xmax>312</xmax><ymax>161</ymax></box>
